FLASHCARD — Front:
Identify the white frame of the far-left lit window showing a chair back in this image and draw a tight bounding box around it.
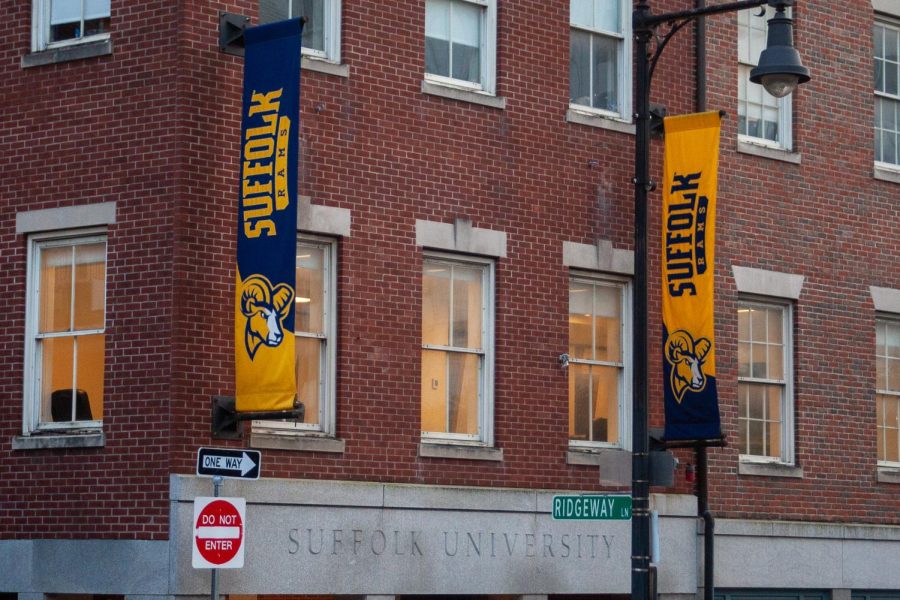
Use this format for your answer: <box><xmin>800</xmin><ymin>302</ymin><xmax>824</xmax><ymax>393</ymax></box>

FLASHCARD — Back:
<box><xmin>22</xmin><ymin>228</ymin><xmax>109</xmax><ymax>435</ymax></box>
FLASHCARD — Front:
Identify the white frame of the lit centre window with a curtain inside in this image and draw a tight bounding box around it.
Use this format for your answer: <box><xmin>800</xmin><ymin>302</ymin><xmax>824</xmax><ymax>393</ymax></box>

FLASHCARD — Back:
<box><xmin>419</xmin><ymin>250</ymin><xmax>496</xmax><ymax>447</ymax></box>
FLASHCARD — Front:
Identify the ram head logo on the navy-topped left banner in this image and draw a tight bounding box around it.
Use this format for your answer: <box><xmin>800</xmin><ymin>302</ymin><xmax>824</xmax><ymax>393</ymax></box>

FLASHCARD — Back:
<box><xmin>241</xmin><ymin>275</ymin><xmax>294</xmax><ymax>360</ymax></box>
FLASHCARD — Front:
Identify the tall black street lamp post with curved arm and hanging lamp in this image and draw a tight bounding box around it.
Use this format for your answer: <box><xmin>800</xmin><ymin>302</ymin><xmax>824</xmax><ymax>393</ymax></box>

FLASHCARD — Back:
<box><xmin>631</xmin><ymin>0</ymin><xmax>809</xmax><ymax>600</ymax></box>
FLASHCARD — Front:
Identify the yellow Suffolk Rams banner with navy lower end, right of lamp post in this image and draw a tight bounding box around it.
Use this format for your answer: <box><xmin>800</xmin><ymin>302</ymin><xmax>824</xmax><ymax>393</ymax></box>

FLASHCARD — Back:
<box><xmin>662</xmin><ymin>112</ymin><xmax>722</xmax><ymax>441</ymax></box>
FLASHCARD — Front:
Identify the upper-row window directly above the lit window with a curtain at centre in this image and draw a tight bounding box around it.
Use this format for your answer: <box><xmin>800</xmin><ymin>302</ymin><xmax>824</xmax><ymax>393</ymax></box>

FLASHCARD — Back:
<box><xmin>425</xmin><ymin>0</ymin><xmax>497</xmax><ymax>94</ymax></box>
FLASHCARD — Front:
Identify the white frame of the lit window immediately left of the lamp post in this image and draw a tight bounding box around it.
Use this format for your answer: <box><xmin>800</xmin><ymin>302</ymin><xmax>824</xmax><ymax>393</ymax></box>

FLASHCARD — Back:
<box><xmin>567</xmin><ymin>271</ymin><xmax>633</xmax><ymax>450</ymax></box>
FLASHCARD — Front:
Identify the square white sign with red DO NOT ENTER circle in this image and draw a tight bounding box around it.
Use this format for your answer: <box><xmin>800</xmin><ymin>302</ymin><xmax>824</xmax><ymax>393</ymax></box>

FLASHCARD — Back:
<box><xmin>191</xmin><ymin>498</ymin><xmax>246</xmax><ymax>569</ymax></box>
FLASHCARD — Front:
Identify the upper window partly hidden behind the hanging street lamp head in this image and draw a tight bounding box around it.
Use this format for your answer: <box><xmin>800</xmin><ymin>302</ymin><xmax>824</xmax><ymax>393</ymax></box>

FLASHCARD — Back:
<box><xmin>738</xmin><ymin>6</ymin><xmax>791</xmax><ymax>150</ymax></box>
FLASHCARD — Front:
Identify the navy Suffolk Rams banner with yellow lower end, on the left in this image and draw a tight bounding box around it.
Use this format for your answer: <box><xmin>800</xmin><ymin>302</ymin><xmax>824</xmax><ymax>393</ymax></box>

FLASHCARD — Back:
<box><xmin>234</xmin><ymin>19</ymin><xmax>303</xmax><ymax>412</ymax></box>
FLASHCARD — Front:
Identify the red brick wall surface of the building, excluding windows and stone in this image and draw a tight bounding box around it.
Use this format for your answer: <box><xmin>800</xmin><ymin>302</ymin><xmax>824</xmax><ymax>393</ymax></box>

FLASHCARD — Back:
<box><xmin>0</xmin><ymin>0</ymin><xmax>900</xmax><ymax>538</ymax></box>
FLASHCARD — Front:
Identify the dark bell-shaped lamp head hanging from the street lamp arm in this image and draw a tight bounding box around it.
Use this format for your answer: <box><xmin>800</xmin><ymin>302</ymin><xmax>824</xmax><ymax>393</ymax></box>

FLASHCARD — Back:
<box><xmin>750</xmin><ymin>0</ymin><xmax>809</xmax><ymax>98</ymax></box>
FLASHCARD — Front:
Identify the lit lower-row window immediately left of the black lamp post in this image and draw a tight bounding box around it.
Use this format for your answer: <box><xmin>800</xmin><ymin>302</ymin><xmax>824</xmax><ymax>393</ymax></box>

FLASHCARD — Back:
<box><xmin>569</xmin><ymin>277</ymin><xmax>631</xmax><ymax>447</ymax></box>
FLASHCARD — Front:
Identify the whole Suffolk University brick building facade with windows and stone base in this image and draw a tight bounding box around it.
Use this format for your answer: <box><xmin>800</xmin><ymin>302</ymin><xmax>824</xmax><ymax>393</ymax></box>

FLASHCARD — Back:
<box><xmin>0</xmin><ymin>0</ymin><xmax>900</xmax><ymax>599</ymax></box>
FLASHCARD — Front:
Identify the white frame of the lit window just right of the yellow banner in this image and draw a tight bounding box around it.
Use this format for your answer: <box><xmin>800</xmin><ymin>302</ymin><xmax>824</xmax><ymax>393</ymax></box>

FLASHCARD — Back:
<box><xmin>736</xmin><ymin>294</ymin><xmax>795</xmax><ymax>465</ymax></box>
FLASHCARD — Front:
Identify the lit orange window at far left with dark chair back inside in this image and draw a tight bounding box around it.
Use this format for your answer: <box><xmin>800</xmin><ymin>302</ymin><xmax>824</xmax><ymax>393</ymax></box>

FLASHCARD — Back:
<box><xmin>25</xmin><ymin>232</ymin><xmax>106</xmax><ymax>432</ymax></box>
